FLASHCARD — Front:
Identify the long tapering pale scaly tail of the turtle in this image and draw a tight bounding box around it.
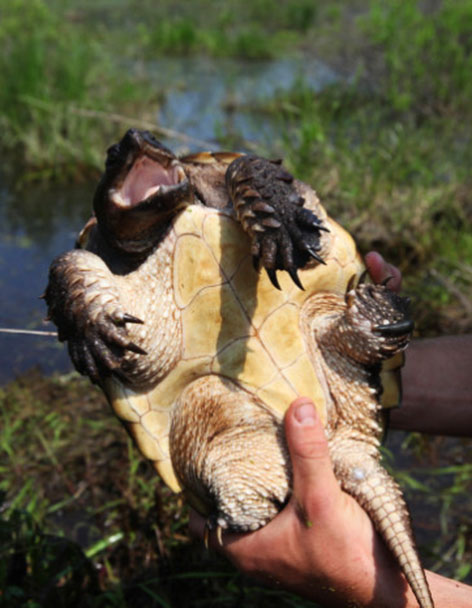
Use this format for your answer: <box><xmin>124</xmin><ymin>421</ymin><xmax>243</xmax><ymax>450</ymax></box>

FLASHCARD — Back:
<box><xmin>330</xmin><ymin>437</ymin><xmax>434</xmax><ymax>608</ymax></box>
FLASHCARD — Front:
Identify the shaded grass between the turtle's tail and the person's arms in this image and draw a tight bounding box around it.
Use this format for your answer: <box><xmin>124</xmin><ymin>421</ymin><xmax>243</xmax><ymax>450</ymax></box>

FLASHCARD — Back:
<box><xmin>386</xmin><ymin>433</ymin><xmax>472</xmax><ymax>583</ymax></box>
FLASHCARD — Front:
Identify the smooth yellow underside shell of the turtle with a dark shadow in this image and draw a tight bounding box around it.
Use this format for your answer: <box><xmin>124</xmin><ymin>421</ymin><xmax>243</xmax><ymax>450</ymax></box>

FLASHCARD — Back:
<box><xmin>105</xmin><ymin>205</ymin><xmax>368</xmax><ymax>491</ymax></box>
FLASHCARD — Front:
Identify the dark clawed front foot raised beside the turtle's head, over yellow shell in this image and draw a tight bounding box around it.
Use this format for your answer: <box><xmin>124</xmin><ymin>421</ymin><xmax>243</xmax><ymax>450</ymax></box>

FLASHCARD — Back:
<box><xmin>226</xmin><ymin>156</ymin><xmax>327</xmax><ymax>289</ymax></box>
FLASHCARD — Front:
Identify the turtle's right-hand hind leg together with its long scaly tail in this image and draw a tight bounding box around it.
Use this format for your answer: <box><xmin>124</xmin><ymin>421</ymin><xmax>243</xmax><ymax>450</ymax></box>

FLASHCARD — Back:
<box><xmin>305</xmin><ymin>285</ymin><xmax>433</xmax><ymax>608</ymax></box>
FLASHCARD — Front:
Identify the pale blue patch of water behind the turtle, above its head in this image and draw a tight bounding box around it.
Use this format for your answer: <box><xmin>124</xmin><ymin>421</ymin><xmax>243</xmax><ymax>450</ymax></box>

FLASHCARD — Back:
<box><xmin>151</xmin><ymin>57</ymin><xmax>339</xmax><ymax>152</ymax></box>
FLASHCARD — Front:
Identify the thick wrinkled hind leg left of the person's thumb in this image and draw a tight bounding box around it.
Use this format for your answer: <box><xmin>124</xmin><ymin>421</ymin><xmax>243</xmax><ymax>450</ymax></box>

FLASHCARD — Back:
<box><xmin>169</xmin><ymin>376</ymin><xmax>290</xmax><ymax>532</ymax></box>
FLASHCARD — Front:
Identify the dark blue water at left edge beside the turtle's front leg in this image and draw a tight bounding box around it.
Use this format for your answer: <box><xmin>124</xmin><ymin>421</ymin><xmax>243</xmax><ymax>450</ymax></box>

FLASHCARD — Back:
<box><xmin>0</xmin><ymin>173</ymin><xmax>93</xmax><ymax>382</ymax></box>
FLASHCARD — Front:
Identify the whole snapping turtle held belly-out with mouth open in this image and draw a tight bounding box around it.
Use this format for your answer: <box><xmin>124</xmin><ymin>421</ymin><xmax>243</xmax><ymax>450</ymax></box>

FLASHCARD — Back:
<box><xmin>46</xmin><ymin>130</ymin><xmax>433</xmax><ymax>608</ymax></box>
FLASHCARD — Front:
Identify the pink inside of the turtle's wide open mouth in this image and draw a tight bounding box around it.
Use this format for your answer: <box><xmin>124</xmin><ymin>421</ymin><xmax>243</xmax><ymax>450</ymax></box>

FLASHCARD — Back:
<box><xmin>110</xmin><ymin>154</ymin><xmax>187</xmax><ymax>207</ymax></box>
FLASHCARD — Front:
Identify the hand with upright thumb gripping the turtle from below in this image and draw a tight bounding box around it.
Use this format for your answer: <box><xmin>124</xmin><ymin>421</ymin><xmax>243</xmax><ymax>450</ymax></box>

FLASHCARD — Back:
<box><xmin>190</xmin><ymin>397</ymin><xmax>410</xmax><ymax>607</ymax></box>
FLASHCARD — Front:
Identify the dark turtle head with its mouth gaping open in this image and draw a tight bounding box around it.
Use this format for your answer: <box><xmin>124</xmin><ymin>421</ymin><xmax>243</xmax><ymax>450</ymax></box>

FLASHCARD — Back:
<box><xmin>93</xmin><ymin>129</ymin><xmax>192</xmax><ymax>255</ymax></box>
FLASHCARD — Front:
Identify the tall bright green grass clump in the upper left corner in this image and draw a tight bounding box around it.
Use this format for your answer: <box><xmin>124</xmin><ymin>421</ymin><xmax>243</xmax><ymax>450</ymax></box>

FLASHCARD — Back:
<box><xmin>0</xmin><ymin>0</ymin><xmax>155</xmax><ymax>179</ymax></box>
